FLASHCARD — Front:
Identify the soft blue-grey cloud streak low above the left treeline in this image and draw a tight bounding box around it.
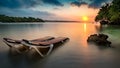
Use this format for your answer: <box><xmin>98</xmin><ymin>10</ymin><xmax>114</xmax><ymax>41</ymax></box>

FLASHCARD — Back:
<box><xmin>0</xmin><ymin>8</ymin><xmax>55</xmax><ymax>19</ymax></box>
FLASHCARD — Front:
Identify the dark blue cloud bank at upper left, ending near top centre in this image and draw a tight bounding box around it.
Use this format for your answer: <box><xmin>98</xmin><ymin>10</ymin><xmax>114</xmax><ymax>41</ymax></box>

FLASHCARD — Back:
<box><xmin>0</xmin><ymin>0</ymin><xmax>63</xmax><ymax>8</ymax></box>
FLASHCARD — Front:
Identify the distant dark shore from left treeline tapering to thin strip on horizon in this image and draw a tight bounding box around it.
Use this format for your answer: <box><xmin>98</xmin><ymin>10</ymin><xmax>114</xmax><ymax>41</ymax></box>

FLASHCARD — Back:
<box><xmin>0</xmin><ymin>15</ymin><xmax>80</xmax><ymax>23</ymax></box>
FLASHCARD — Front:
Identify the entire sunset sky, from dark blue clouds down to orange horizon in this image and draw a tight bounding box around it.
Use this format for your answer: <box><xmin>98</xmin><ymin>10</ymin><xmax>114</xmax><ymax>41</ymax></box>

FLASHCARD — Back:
<box><xmin>0</xmin><ymin>0</ymin><xmax>112</xmax><ymax>21</ymax></box>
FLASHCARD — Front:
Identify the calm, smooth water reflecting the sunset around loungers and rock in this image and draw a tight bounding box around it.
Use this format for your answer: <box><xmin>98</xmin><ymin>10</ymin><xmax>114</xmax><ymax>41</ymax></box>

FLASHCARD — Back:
<box><xmin>0</xmin><ymin>23</ymin><xmax>120</xmax><ymax>68</ymax></box>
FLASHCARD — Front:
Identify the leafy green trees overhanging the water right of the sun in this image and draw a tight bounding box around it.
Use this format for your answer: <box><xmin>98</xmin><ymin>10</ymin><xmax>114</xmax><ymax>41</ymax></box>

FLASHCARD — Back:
<box><xmin>95</xmin><ymin>0</ymin><xmax>120</xmax><ymax>25</ymax></box>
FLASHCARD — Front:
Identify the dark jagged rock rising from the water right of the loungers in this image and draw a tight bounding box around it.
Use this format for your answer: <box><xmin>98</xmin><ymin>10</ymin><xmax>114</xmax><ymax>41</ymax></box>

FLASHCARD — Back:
<box><xmin>87</xmin><ymin>34</ymin><xmax>111</xmax><ymax>46</ymax></box>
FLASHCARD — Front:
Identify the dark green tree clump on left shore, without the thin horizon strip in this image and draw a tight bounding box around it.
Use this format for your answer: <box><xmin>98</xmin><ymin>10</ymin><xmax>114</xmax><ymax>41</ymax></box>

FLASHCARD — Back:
<box><xmin>0</xmin><ymin>15</ymin><xmax>44</xmax><ymax>22</ymax></box>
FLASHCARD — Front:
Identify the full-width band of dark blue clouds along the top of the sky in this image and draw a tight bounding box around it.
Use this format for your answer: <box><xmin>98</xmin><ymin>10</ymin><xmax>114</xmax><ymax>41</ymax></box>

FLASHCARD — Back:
<box><xmin>0</xmin><ymin>0</ymin><xmax>112</xmax><ymax>9</ymax></box>
